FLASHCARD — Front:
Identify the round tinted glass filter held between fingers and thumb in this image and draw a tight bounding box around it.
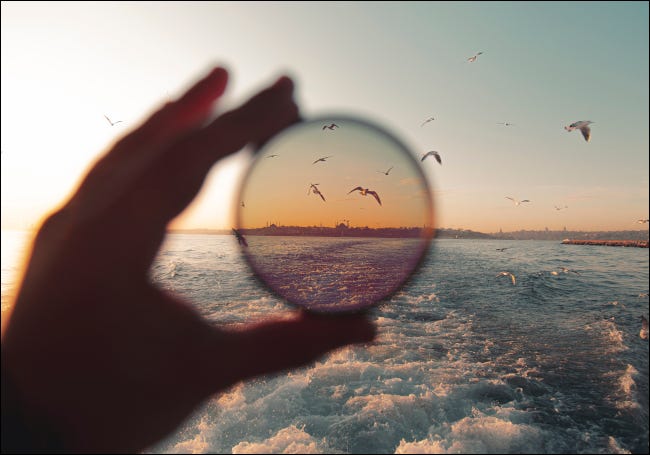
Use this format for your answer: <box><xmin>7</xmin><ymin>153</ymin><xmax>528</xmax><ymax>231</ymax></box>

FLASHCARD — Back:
<box><xmin>233</xmin><ymin>116</ymin><xmax>434</xmax><ymax>313</ymax></box>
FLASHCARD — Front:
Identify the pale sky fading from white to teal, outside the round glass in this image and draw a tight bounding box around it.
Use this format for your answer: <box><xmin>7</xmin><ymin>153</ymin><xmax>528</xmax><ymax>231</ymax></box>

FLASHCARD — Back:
<box><xmin>0</xmin><ymin>1</ymin><xmax>649</xmax><ymax>232</ymax></box>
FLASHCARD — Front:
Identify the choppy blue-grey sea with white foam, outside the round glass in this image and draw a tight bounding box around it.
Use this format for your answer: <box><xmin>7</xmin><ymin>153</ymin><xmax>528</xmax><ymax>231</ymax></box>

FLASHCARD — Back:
<box><xmin>2</xmin><ymin>231</ymin><xmax>649</xmax><ymax>454</ymax></box>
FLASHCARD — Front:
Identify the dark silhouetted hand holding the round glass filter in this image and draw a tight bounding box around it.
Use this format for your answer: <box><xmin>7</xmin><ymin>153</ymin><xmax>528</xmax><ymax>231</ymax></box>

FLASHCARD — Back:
<box><xmin>2</xmin><ymin>68</ymin><xmax>375</xmax><ymax>452</ymax></box>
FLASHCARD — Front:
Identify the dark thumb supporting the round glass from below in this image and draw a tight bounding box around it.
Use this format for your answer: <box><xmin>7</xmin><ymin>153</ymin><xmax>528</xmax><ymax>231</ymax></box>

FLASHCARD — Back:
<box><xmin>201</xmin><ymin>313</ymin><xmax>376</xmax><ymax>391</ymax></box>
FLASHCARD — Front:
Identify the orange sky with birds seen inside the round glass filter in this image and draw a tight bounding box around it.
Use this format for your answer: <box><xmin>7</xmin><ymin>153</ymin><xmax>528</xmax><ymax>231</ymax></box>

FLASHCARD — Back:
<box><xmin>236</xmin><ymin>119</ymin><xmax>433</xmax><ymax>229</ymax></box>
